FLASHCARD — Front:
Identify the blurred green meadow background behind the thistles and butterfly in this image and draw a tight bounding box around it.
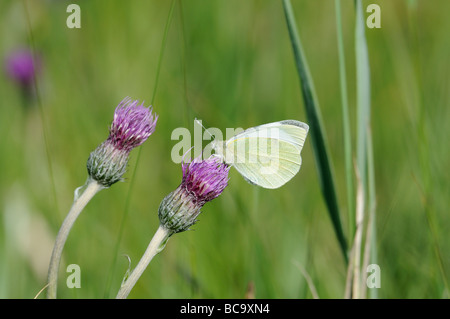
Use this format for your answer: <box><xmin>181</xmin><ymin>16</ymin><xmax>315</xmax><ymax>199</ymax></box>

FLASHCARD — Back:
<box><xmin>0</xmin><ymin>0</ymin><xmax>450</xmax><ymax>298</ymax></box>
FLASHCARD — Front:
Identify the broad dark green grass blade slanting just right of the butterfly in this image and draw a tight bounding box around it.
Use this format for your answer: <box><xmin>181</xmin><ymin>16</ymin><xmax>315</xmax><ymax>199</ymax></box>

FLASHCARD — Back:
<box><xmin>283</xmin><ymin>0</ymin><xmax>348</xmax><ymax>263</ymax></box>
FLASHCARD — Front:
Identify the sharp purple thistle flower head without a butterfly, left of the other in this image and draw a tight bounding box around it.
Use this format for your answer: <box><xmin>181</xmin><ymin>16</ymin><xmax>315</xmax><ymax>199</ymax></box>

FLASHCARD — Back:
<box><xmin>87</xmin><ymin>98</ymin><xmax>158</xmax><ymax>187</ymax></box>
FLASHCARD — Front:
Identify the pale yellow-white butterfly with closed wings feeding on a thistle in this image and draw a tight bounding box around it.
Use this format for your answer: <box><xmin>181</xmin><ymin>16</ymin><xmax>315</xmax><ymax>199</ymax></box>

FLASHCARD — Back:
<box><xmin>211</xmin><ymin>120</ymin><xmax>309</xmax><ymax>188</ymax></box>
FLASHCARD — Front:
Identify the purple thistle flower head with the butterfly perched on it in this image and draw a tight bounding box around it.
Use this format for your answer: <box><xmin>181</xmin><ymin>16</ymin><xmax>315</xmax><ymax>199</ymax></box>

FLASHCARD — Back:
<box><xmin>158</xmin><ymin>156</ymin><xmax>230</xmax><ymax>233</ymax></box>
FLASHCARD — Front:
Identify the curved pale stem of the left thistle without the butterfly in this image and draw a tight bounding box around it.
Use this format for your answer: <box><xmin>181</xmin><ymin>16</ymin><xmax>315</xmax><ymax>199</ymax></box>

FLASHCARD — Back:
<box><xmin>47</xmin><ymin>178</ymin><xmax>104</xmax><ymax>299</ymax></box>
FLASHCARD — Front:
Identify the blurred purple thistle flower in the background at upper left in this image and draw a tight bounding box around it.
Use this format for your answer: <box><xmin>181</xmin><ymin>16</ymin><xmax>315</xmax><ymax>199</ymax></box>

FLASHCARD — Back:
<box><xmin>5</xmin><ymin>49</ymin><xmax>40</xmax><ymax>90</ymax></box>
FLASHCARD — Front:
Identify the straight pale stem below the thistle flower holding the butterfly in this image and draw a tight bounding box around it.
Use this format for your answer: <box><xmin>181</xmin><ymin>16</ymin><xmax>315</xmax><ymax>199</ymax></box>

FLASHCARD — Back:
<box><xmin>116</xmin><ymin>225</ymin><xmax>172</xmax><ymax>299</ymax></box>
